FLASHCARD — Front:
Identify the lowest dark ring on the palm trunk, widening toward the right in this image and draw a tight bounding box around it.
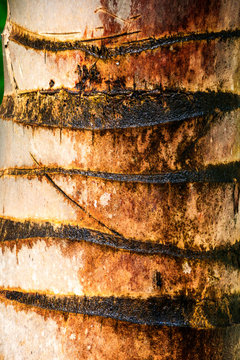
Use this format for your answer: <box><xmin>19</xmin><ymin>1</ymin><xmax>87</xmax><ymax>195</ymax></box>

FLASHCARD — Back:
<box><xmin>0</xmin><ymin>290</ymin><xmax>240</xmax><ymax>328</ymax></box>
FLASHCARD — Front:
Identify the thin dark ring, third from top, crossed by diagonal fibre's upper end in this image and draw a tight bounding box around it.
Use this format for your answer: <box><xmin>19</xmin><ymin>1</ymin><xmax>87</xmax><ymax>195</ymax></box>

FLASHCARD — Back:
<box><xmin>0</xmin><ymin>162</ymin><xmax>240</xmax><ymax>184</ymax></box>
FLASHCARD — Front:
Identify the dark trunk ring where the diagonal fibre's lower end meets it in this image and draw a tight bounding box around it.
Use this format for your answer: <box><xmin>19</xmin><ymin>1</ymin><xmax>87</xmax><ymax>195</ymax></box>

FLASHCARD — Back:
<box><xmin>0</xmin><ymin>218</ymin><xmax>240</xmax><ymax>269</ymax></box>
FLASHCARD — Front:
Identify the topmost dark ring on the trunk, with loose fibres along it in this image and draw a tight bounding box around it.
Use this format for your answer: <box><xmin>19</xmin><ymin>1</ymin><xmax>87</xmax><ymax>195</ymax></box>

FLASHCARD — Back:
<box><xmin>9</xmin><ymin>23</ymin><xmax>240</xmax><ymax>60</ymax></box>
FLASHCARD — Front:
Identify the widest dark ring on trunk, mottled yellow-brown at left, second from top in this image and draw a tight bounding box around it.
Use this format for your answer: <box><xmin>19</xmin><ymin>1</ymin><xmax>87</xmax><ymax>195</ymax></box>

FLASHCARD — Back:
<box><xmin>0</xmin><ymin>90</ymin><xmax>240</xmax><ymax>130</ymax></box>
